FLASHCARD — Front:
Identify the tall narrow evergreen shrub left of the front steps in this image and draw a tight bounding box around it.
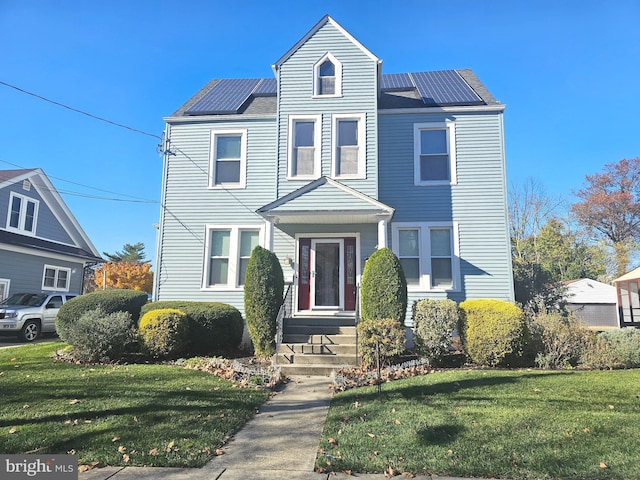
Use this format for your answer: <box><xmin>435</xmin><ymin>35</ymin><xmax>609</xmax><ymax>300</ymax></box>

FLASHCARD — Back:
<box><xmin>244</xmin><ymin>246</ymin><xmax>284</xmax><ymax>357</ymax></box>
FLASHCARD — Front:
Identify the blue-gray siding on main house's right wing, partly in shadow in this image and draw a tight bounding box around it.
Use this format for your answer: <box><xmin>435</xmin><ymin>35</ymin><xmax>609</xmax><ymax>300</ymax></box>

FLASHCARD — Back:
<box><xmin>378</xmin><ymin>113</ymin><xmax>513</xmax><ymax>314</ymax></box>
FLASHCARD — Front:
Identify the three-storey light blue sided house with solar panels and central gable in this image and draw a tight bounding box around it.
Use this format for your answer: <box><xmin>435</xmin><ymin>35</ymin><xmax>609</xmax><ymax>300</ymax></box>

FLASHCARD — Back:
<box><xmin>154</xmin><ymin>16</ymin><xmax>514</xmax><ymax>374</ymax></box>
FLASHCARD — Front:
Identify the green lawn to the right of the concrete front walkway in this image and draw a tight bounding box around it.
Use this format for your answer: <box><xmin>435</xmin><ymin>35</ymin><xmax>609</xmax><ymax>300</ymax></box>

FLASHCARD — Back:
<box><xmin>318</xmin><ymin>370</ymin><xmax>640</xmax><ymax>480</ymax></box>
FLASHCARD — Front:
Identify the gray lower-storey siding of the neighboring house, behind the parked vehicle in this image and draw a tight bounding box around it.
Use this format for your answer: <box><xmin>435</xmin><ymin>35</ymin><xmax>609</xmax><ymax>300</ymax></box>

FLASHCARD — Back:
<box><xmin>0</xmin><ymin>249</ymin><xmax>83</xmax><ymax>294</ymax></box>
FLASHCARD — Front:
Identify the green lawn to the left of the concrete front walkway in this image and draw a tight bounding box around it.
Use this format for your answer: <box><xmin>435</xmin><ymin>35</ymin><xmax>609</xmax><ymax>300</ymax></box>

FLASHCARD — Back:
<box><xmin>0</xmin><ymin>342</ymin><xmax>268</xmax><ymax>467</ymax></box>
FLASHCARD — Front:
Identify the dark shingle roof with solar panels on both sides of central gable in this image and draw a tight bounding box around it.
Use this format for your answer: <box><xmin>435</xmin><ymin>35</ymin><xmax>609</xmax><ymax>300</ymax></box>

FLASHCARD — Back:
<box><xmin>171</xmin><ymin>69</ymin><xmax>500</xmax><ymax>117</ymax></box>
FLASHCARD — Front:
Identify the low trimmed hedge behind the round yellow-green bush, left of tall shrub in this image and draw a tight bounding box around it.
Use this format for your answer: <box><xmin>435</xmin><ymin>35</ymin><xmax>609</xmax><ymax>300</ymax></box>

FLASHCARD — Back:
<box><xmin>141</xmin><ymin>300</ymin><xmax>244</xmax><ymax>354</ymax></box>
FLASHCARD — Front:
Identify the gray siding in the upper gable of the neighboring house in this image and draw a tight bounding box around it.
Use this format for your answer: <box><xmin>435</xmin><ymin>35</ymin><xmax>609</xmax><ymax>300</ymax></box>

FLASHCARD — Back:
<box><xmin>0</xmin><ymin>182</ymin><xmax>73</xmax><ymax>247</ymax></box>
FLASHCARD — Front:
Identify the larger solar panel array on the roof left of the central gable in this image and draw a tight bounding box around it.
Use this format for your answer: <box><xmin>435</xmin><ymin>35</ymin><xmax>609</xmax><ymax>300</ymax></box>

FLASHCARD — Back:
<box><xmin>186</xmin><ymin>78</ymin><xmax>260</xmax><ymax>115</ymax></box>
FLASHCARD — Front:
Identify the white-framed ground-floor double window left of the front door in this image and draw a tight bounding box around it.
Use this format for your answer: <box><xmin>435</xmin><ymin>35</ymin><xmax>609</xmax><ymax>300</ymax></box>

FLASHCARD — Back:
<box><xmin>203</xmin><ymin>226</ymin><xmax>262</xmax><ymax>289</ymax></box>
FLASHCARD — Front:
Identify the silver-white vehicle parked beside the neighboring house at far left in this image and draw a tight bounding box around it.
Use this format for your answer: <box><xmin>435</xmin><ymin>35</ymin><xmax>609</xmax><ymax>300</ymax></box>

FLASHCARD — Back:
<box><xmin>0</xmin><ymin>293</ymin><xmax>78</xmax><ymax>342</ymax></box>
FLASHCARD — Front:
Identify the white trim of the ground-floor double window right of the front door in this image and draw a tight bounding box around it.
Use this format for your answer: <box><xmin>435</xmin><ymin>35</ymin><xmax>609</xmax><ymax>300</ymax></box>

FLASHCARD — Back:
<box><xmin>391</xmin><ymin>222</ymin><xmax>461</xmax><ymax>292</ymax></box>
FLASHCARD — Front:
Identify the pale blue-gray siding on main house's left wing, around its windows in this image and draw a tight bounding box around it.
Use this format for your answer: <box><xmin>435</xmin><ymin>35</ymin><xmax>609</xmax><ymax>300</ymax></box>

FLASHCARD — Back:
<box><xmin>157</xmin><ymin>118</ymin><xmax>276</xmax><ymax>304</ymax></box>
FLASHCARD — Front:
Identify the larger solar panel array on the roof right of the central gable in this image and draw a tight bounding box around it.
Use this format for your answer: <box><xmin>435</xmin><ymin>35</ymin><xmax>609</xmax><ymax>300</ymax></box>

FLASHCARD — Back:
<box><xmin>411</xmin><ymin>70</ymin><xmax>483</xmax><ymax>105</ymax></box>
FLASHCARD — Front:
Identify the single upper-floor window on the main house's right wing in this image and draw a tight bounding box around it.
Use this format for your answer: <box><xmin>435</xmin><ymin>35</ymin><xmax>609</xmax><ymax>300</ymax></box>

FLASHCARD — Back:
<box><xmin>413</xmin><ymin>122</ymin><xmax>456</xmax><ymax>185</ymax></box>
